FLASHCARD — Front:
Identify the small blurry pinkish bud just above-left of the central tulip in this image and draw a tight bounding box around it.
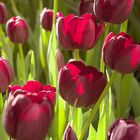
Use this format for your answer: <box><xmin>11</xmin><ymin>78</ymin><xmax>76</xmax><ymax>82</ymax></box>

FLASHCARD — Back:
<box><xmin>56</xmin><ymin>49</ymin><xmax>65</xmax><ymax>70</ymax></box>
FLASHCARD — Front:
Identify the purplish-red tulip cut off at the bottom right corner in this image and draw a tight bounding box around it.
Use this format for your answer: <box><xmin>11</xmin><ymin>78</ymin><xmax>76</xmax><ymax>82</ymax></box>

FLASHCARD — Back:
<box><xmin>108</xmin><ymin>119</ymin><xmax>140</xmax><ymax>140</ymax></box>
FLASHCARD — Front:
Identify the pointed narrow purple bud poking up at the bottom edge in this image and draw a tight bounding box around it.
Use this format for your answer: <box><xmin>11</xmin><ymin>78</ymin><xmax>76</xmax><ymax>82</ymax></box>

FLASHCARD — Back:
<box><xmin>64</xmin><ymin>125</ymin><xmax>78</xmax><ymax>140</ymax></box>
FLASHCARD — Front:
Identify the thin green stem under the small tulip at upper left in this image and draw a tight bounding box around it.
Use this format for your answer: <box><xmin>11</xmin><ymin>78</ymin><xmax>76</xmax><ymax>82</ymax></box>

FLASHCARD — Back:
<box><xmin>18</xmin><ymin>44</ymin><xmax>26</xmax><ymax>82</ymax></box>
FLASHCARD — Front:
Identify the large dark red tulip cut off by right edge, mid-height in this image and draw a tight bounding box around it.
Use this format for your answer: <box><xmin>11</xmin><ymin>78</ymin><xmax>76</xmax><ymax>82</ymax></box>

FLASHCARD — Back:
<box><xmin>103</xmin><ymin>32</ymin><xmax>140</xmax><ymax>74</ymax></box>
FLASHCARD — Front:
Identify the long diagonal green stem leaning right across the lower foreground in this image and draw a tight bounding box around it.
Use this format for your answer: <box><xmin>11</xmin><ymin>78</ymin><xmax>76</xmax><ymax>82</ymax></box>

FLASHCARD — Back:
<box><xmin>79</xmin><ymin>71</ymin><xmax>116</xmax><ymax>140</ymax></box>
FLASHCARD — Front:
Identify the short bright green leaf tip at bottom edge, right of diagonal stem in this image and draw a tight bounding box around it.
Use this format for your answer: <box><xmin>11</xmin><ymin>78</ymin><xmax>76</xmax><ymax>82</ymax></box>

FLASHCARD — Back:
<box><xmin>87</xmin><ymin>124</ymin><xmax>97</xmax><ymax>140</ymax></box>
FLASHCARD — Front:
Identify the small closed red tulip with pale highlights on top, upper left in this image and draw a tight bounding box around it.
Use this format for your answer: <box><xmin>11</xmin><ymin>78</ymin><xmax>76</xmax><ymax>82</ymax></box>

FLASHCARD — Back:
<box><xmin>6</xmin><ymin>16</ymin><xmax>29</xmax><ymax>43</ymax></box>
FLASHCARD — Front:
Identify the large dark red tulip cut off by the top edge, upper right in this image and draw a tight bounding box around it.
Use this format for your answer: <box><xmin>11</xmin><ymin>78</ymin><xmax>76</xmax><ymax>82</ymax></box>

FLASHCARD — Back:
<box><xmin>93</xmin><ymin>0</ymin><xmax>134</xmax><ymax>24</ymax></box>
